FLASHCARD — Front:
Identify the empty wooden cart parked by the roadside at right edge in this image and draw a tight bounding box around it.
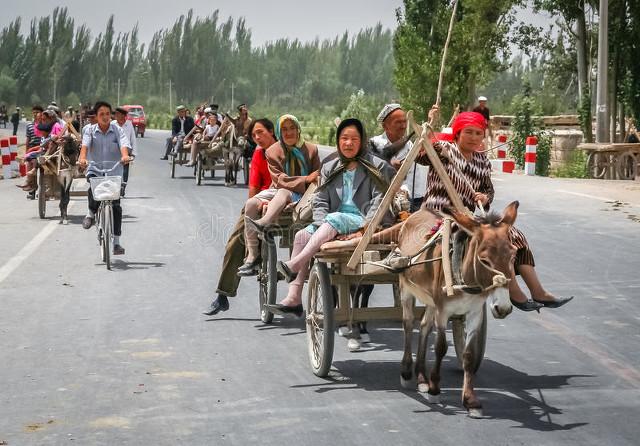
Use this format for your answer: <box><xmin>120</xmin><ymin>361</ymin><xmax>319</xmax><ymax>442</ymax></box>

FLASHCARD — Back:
<box><xmin>578</xmin><ymin>143</ymin><xmax>640</xmax><ymax>180</ymax></box>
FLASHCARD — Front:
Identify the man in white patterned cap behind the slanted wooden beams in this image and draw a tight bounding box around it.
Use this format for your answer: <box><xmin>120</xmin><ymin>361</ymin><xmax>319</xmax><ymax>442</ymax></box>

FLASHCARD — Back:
<box><xmin>370</xmin><ymin>103</ymin><xmax>428</xmax><ymax>212</ymax></box>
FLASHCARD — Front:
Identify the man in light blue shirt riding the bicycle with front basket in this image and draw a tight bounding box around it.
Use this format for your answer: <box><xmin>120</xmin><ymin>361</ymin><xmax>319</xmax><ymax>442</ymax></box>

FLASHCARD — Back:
<box><xmin>79</xmin><ymin>101</ymin><xmax>132</xmax><ymax>255</ymax></box>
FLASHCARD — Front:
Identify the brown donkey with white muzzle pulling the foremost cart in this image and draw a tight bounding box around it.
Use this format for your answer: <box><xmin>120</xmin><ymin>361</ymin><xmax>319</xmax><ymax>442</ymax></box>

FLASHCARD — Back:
<box><xmin>399</xmin><ymin>201</ymin><xmax>518</xmax><ymax>417</ymax></box>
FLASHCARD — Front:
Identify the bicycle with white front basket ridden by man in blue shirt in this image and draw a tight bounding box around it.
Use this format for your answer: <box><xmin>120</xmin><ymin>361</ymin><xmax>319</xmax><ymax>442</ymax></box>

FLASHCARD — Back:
<box><xmin>89</xmin><ymin>161</ymin><xmax>131</xmax><ymax>271</ymax></box>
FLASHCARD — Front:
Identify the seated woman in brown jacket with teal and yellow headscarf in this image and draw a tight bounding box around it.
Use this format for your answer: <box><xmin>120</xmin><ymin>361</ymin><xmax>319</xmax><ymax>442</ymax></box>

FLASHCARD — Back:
<box><xmin>238</xmin><ymin>115</ymin><xmax>320</xmax><ymax>276</ymax></box>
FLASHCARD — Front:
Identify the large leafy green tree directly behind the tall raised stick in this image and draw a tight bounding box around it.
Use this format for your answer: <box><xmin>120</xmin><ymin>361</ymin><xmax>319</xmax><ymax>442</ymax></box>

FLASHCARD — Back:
<box><xmin>394</xmin><ymin>0</ymin><xmax>522</xmax><ymax>121</ymax></box>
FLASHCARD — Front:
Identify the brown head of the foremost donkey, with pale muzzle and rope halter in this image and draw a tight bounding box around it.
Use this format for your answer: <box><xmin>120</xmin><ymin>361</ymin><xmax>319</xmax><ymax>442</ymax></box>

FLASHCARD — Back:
<box><xmin>450</xmin><ymin>201</ymin><xmax>519</xmax><ymax>319</ymax></box>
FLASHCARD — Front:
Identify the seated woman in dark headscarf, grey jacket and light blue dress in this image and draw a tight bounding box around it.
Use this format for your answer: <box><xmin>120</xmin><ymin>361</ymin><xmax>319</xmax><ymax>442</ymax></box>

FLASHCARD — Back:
<box><xmin>271</xmin><ymin>118</ymin><xmax>395</xmax><ymax>316</ymax></box>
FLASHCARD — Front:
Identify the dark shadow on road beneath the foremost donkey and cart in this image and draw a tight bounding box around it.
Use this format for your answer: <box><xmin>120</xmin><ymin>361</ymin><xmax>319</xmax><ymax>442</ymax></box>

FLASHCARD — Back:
<box><xmin>292</xmin><ymin>355</ymin><xmax>593</xmax><ymax>432</ymax></box>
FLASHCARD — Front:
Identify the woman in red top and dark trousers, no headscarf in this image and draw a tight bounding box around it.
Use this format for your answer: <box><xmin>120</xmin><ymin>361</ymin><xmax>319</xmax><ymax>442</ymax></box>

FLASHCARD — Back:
<box><xmin>204</xmin><ymin>118</ymin><xmax>276</xmax><ymax>316</ymax></box>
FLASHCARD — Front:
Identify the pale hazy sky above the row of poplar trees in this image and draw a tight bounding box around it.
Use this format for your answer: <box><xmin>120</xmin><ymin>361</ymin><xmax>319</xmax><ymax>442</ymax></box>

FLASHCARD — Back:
<box><xmin>0</xmin><ymin>0</ymin><xmax>402</xmax><ymax>45</ymax></box>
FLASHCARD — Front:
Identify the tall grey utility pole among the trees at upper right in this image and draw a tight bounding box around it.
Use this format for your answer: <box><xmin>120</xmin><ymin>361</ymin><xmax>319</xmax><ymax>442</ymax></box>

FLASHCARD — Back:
<box><xmin>596</xmin><ymin>0</ymin><xmax>609</xmax><ymax>142</ymax></box>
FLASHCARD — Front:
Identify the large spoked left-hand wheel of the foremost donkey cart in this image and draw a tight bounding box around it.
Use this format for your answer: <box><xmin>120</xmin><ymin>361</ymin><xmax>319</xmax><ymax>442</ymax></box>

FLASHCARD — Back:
<box><xmin>307</xmin><ymin>262</ymin><xmax>334</xmax><ymax>378</ymax></box>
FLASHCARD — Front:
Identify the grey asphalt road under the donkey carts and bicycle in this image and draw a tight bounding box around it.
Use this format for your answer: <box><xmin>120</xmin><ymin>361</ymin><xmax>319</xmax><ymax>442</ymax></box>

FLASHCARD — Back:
<box><xmin>0</xmin><ymin>127</ymin><xmax>640</xmax><ymax>446</ymax></box>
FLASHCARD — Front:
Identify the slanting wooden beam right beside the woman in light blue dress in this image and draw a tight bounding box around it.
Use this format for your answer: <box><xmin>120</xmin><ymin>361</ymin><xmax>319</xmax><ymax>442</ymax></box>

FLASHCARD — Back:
<box><xmin>347</xmin><ymin>111</ymin><xmax>427</xmax><ymax>269</ymax></box>
